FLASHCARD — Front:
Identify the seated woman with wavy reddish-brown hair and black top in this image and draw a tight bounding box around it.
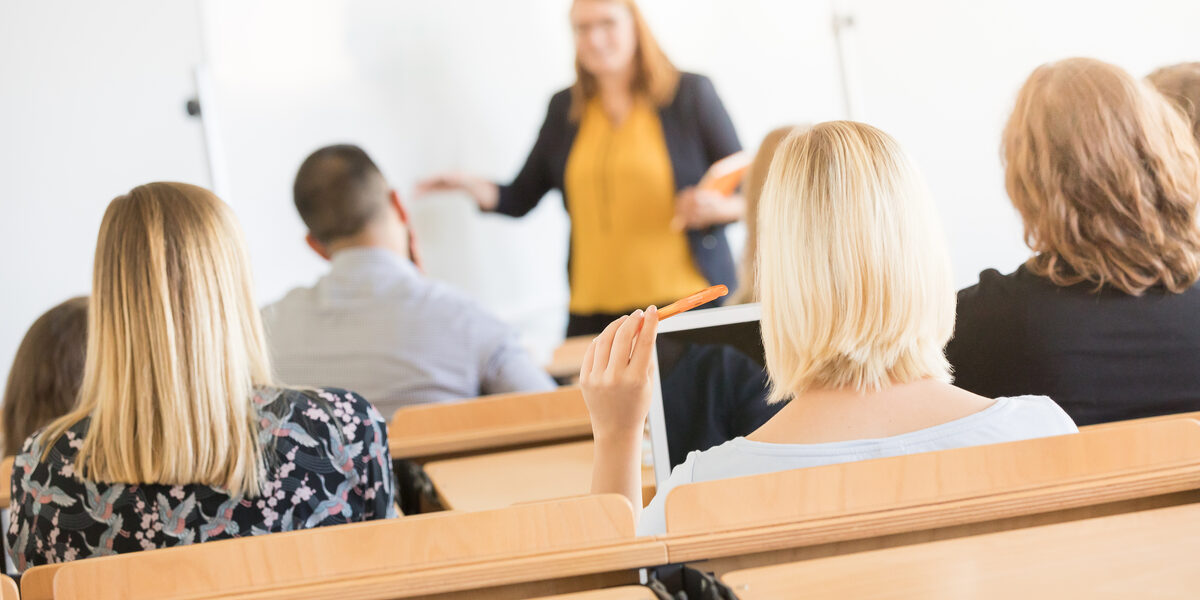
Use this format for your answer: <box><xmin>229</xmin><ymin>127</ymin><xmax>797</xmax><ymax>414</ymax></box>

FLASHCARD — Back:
<box><xmin>947</xmin><ymin>59</ymin><xmax>1200</xmax><ymax>425</ymax></box>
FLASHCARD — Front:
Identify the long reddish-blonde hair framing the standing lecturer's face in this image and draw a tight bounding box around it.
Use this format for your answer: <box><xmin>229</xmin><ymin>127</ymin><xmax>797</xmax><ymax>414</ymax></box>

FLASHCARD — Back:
<box><xmin>569</xmin><ymin>0</ymin><xmax>679</xmax><ymax>121</ymax></box>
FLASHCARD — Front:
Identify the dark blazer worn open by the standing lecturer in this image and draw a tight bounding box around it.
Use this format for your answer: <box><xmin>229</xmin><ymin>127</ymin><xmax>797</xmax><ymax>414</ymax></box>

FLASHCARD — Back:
<box><xmin>496</xmin><ymin>73</ymin><xmax>742</xmax><ymax>298</ymax></box>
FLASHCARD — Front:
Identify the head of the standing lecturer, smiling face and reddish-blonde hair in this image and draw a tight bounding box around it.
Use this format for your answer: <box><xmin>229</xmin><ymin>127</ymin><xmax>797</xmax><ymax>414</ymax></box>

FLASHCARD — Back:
<box><xmin>570</xmin><ymin>0</ymin><xmax>679</xmax><ymax>120</ymax></box>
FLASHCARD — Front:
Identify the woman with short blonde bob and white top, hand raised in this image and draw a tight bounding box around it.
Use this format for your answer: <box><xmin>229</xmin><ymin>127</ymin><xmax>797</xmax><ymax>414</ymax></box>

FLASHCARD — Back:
<box><xmin>581</xmin><ymin>121</ymin><xmax>1076</xmax><ymax>534</ymax></box>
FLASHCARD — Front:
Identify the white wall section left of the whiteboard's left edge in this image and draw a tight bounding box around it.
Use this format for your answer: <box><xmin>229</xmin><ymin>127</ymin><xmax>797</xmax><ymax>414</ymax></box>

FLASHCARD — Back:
<box><xmin>0</xmin><ymin>0</ymin><xmax>208</xmax><ymax>382</ymax></box>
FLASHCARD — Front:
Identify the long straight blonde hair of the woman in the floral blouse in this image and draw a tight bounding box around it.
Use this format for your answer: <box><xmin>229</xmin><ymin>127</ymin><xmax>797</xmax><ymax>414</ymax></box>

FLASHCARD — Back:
<box><xmin>43</xmin><ymin>182</ymin><xmax>272</xmax><ymax>497</ymax></box>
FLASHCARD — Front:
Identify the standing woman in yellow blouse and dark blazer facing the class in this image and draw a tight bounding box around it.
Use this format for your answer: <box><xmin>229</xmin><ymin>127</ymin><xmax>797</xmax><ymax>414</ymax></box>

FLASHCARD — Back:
<box><xmin>420</xmin><ymin>0</ymin><xmax>745</xmax><ymax>336</ymax></box>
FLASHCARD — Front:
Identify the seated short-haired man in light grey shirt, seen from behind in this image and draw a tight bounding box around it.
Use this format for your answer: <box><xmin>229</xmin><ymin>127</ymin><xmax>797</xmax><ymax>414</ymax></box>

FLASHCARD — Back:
<box><xmin>263</xmin><ymin>145</ymin><xmax>554</xmax><ymax>418</ymax></box>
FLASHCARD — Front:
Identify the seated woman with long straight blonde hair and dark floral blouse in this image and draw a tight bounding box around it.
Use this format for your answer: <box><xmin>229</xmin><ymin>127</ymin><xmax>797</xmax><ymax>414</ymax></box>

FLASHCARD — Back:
<box><xmin>8</xmin><ymin>184</ymin><xmax>395</xmax><ymax>571</ymax></box>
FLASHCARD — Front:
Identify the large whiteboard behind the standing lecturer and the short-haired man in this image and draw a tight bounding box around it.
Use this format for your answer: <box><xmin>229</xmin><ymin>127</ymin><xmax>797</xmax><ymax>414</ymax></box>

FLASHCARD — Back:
<box><xmin>205</xmin><ymin>0</ymin><xmax>838</xmax><ymax>355</ymax></box>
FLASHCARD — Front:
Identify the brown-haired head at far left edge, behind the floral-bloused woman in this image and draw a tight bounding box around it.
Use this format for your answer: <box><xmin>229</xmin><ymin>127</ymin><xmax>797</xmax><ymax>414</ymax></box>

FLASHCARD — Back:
<box><xmin>2</xmin><ymin>296</ymin><xmax>88</xmax><ymax>456</ymax></box>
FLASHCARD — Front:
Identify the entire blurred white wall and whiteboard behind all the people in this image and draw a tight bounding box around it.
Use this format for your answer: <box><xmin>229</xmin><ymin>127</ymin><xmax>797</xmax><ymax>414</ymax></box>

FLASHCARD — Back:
<box><xmin>0</xmin><ymin>0</ymin><xmax>1200</xmax><ymax>376</ymax></box>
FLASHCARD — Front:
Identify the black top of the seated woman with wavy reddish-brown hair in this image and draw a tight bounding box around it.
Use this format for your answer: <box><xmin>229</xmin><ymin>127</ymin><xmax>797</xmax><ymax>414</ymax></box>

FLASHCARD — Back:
<box><xmin>946</xmin><ymin>266</ymin><xmax>1200</xmax><ymax>425</ymax></box>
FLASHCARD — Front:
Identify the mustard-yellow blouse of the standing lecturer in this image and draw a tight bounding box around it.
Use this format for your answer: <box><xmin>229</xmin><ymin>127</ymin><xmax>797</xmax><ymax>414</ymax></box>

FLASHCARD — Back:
<box><xmin>564</xmin><ymin>98</ymin><xmax>708</xmax><ymax>314</ymax></box>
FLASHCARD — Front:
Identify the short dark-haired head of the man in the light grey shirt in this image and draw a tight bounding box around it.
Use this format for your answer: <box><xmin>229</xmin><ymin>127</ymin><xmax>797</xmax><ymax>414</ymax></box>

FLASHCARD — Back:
<box><xmin>293</xmin><ymin>144</ymin><xmax>412</xmax><ymax>258</ymax></box>
